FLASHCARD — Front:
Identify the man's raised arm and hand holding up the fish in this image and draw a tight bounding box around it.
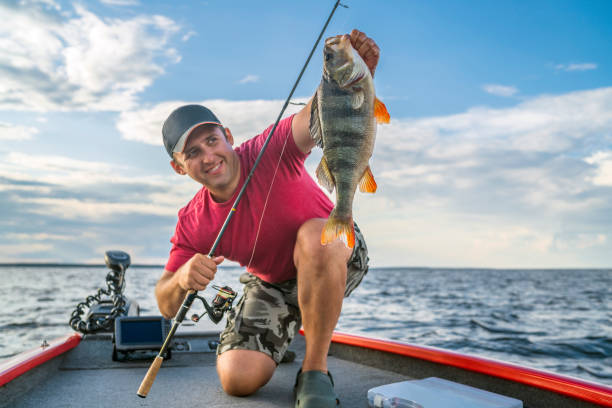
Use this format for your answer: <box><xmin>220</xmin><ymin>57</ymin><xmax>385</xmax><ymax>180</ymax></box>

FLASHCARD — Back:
<box><xmin>291</xmin><ymin>30</ymin><xmax>380</xmax><ymax>153</ymax></box>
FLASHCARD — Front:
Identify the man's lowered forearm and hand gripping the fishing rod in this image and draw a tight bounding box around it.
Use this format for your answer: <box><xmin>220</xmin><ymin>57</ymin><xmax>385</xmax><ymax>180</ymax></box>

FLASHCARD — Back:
<box><xmin>155</xmin><ymin>254</ymin><xmax>224</xmax><ymax>319</ymax></box>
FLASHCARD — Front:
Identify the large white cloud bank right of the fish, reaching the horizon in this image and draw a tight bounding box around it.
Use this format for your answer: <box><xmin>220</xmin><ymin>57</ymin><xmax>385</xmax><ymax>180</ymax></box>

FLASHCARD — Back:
<box><xmin>355</xmin><ymin>88</ymin><xmax>612</xmax><ymax>267</ymax></box>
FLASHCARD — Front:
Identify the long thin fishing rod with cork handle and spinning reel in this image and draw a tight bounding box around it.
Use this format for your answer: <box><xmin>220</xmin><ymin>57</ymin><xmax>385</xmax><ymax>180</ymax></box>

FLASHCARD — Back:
<box><xmin>136</xmin><ymin>0</ymin><xmax>347</xmax><ymax>398</ymax></box>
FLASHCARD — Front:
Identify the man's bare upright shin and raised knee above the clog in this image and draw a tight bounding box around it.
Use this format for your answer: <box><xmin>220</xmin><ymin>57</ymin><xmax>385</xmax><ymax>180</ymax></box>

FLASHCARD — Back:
<box><xmin>293</xmin><ymin>218</ymin><xmax>352</xmax><ymax>372</ymax></box>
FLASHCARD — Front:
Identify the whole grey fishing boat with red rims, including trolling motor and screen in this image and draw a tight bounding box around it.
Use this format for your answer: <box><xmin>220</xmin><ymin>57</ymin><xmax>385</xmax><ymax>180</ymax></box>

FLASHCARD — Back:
<box><xmin>0</xmin><ymin>251</ymin><xmax>612</xmax><ymax>408</ymax></box>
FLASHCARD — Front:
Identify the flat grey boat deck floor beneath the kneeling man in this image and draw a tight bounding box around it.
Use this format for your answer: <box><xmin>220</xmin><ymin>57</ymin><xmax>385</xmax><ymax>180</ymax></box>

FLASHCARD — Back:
<box><xmin>0</xmin><ymin>335</ymin><xmax>408</xmax><ymax>408</ymax></box>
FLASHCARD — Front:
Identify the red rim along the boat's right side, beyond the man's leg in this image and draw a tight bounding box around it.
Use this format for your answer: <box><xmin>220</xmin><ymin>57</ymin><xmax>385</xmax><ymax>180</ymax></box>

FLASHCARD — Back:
<box><xmin>322</xmin><ymin>329</ymin><xmax>612</xmax><ymax>407</ymax></box>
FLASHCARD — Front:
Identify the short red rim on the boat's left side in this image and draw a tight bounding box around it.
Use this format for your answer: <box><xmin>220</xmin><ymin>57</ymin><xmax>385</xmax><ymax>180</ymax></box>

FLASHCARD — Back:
<box><xmin>0</xmin><ymin>333</ymin><xmax>82</xmax><ymax>387</ymax></box>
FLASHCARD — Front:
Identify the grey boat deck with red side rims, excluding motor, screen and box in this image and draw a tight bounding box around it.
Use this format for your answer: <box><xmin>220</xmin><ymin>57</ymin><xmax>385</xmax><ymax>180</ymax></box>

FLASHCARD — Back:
<box><xmin>0</xmin><ymin>322</ymin><xmax>612</xmax><ymax>408</ymax></box>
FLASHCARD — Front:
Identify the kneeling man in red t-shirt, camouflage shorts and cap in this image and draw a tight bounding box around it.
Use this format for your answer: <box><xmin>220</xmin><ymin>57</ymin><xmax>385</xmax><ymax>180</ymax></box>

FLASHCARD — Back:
<box><xmin>155</xmin><ymin>30</ymin><xmax>379</xmax><ymax>408</ymax></box>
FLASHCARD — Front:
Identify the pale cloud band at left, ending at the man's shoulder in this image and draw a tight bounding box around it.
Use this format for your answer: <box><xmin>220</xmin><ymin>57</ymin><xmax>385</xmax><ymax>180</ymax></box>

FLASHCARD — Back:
<box><xmin>0</xmin><ymin>152</ymin><xmax>198</xmax><ymax>220</ymax></box>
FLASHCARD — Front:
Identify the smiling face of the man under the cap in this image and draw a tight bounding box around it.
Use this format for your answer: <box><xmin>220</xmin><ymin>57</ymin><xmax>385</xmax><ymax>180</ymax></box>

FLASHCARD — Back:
<box><xmin>170</xmin><ymin>125</ymin><xmax>240</xmax><ymax>201</ymax></box>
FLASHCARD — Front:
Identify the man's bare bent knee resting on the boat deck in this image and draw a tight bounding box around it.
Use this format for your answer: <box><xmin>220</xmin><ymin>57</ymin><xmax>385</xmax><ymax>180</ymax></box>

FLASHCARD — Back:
<box><xmin>217</xmin><ymin>350</ymin><xmax>276</xmax><ymax>397</ymax></box>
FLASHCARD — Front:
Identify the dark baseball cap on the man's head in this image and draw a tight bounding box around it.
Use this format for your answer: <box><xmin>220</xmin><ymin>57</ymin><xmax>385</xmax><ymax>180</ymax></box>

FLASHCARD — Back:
<box><xmin>162</xmin><ymin>105</ymin><xmax>223</xmax><ymax>157</ymax></box>
